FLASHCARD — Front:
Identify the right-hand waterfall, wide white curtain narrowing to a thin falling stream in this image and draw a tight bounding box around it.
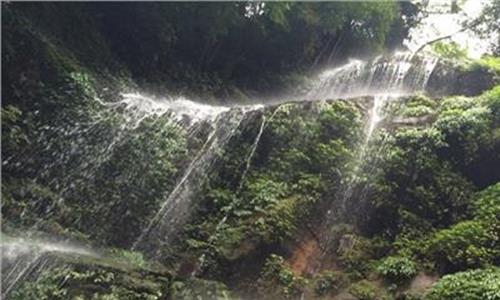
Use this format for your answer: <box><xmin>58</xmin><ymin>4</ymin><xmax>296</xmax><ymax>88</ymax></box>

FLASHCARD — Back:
<box><xmin>310</xmin><ymin>52</ymin><xmax>437</xmax><ymax>268</ymax></box>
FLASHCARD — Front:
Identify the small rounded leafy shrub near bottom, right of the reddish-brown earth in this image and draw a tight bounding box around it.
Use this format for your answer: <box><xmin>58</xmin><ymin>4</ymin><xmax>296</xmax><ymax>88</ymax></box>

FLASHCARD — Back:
<box><xmin>377</xmin><ymin>256</ymin><xmax>417</xmax><ymax>283</ymax></box>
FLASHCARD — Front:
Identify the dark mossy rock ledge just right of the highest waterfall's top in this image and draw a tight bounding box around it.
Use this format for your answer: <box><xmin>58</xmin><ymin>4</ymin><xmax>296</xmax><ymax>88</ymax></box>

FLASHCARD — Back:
<box><xmin>427</xmin><ymin>61</ymin><xmax>500</xmax><ymax>97</ymax></box>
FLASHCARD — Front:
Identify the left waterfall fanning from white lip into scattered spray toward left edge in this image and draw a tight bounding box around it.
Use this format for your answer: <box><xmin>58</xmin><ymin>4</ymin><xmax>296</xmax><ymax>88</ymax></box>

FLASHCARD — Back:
<box><xmin>2</xmin><ymin>93</ymin><xmax>229</xmax><ymax>234</ymax></box>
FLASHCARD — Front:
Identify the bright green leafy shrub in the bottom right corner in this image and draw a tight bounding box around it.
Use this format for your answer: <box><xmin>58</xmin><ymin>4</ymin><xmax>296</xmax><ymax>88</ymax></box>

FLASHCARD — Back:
<box><xmin>426</xmin><ymin>268</ymin><xmax>500</xmax><ymax>300</ymax></box>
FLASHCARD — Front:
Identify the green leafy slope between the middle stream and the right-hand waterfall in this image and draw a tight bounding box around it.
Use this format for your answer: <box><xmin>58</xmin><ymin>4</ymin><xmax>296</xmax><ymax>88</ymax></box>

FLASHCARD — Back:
<box><xmin>180</xmin><ymin>101</ymin><xmax>360</xmax><ymax>274</ymax></box>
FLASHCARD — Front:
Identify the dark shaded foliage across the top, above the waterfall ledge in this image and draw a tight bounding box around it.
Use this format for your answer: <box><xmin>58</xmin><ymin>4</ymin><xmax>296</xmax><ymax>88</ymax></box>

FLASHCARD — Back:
<box><xmin>2</xmin><ymin>2</ymin><xmax>417</xmax><ymax>101</ymax></box>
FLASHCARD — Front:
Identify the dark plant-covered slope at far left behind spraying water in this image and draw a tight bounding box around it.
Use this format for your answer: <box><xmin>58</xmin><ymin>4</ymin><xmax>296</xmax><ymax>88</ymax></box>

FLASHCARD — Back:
<box><xmin>2</xmin><ymin>89</ymin><xmax>191</xmax><ymax>245</ymax></box>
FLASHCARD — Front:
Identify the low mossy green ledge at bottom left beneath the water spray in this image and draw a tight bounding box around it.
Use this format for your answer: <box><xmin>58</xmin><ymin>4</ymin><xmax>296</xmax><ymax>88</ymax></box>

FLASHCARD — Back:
<box><xmin>9</xmin><ymin>258</ymin><xmax>169</xmax><ymax>300</ymax></box>
